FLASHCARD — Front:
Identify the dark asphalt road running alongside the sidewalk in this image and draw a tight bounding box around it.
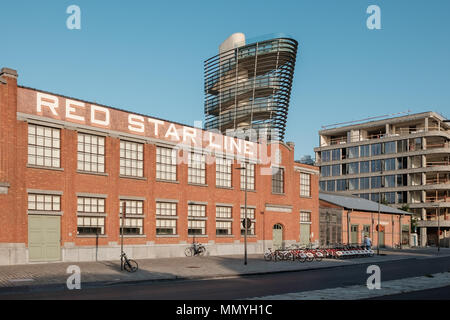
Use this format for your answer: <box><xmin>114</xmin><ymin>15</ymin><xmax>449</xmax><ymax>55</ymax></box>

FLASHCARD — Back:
<box><xmin>0</xmin><ymin>257</ymin><xmax>450</xmax><ymax>300</ymax></box>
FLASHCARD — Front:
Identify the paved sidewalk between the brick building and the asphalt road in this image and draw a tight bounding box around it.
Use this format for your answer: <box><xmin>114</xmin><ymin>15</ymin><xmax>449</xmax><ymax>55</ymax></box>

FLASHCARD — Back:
<box><xmin>0</xmin><ymin>248</ymin><xmax>450</xmax><ymax>295</ymax></box>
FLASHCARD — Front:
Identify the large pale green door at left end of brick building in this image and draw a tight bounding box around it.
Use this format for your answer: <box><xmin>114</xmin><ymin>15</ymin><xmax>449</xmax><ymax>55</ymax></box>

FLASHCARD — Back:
<box><xmin>28</xmin><ymin>216</ymin><xmax>61</xmax><ymax>262</ymax></box>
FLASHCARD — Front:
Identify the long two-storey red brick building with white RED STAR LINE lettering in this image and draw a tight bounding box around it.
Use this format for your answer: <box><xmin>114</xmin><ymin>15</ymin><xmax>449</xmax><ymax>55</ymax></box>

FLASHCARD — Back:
<box><xmin>0</xmin><ymin>68</ymin><xmax>319</xmax><ymax>264</ymax></box>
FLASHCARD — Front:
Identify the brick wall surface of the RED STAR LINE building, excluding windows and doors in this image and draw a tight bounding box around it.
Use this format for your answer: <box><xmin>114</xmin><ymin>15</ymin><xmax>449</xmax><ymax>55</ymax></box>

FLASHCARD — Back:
<box><xmin>0</xmin><ymin>69</ymin><xmax>319</xmax><ymax>264</ymax></box>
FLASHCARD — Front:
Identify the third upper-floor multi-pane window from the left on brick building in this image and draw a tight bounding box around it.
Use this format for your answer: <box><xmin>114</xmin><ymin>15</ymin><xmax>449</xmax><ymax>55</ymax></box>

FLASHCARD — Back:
<box><xmin>120</xmin><ymin>141</ymin><xmax>144</xmax><ymax>177</ymax></box>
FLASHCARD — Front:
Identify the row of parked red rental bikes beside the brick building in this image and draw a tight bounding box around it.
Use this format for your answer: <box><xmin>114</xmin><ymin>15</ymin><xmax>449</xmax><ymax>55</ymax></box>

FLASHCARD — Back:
<box><xmin>264</xmin><ymin>244</ymin><xmax>374</xmax><ymax>262</ymax></box>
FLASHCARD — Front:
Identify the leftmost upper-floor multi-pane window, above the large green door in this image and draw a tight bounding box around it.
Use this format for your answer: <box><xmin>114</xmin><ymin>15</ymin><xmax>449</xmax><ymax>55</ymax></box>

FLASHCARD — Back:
<box><xmin>28</xmin><ymin>124</ymin><xmax>61</xmax><ymax>168</ymax></box>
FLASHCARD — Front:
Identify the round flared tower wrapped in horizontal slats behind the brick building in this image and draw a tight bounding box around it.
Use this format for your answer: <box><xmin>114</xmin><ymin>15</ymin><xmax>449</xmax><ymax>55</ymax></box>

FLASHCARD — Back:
<box><xmin>205</xmin><ymin>33</ymin><xmax>298</xmax><ymax>141</ymax></box>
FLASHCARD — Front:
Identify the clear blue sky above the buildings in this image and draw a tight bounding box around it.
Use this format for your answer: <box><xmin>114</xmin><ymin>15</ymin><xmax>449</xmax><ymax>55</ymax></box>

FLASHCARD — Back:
<box><xmin>0</xmin><ymin>0</ymin><xmax>450</xmax><ymax>159</ymax></box>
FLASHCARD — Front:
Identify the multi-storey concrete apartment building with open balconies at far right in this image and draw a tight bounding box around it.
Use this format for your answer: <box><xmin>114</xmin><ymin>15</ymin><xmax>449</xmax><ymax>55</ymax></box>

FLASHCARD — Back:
<box><xmin>314</xmin><ymin>112</ymin><xmax>450</xmax><ymax>246</ymax></box>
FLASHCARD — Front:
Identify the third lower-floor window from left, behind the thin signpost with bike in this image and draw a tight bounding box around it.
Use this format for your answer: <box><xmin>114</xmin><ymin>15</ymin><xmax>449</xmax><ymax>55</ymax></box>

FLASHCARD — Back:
<box><xmin>119</xmin><ymin>200</ymin><xmax>144</xmax><ymax>235</ymax></box>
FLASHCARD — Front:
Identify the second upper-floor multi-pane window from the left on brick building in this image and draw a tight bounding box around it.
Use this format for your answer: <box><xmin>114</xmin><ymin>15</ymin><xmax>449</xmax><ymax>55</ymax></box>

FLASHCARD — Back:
<box><xmin>77</xmin><ymin>133</ymin><xmax>105</xmax><ymax>173</ymax></box>
